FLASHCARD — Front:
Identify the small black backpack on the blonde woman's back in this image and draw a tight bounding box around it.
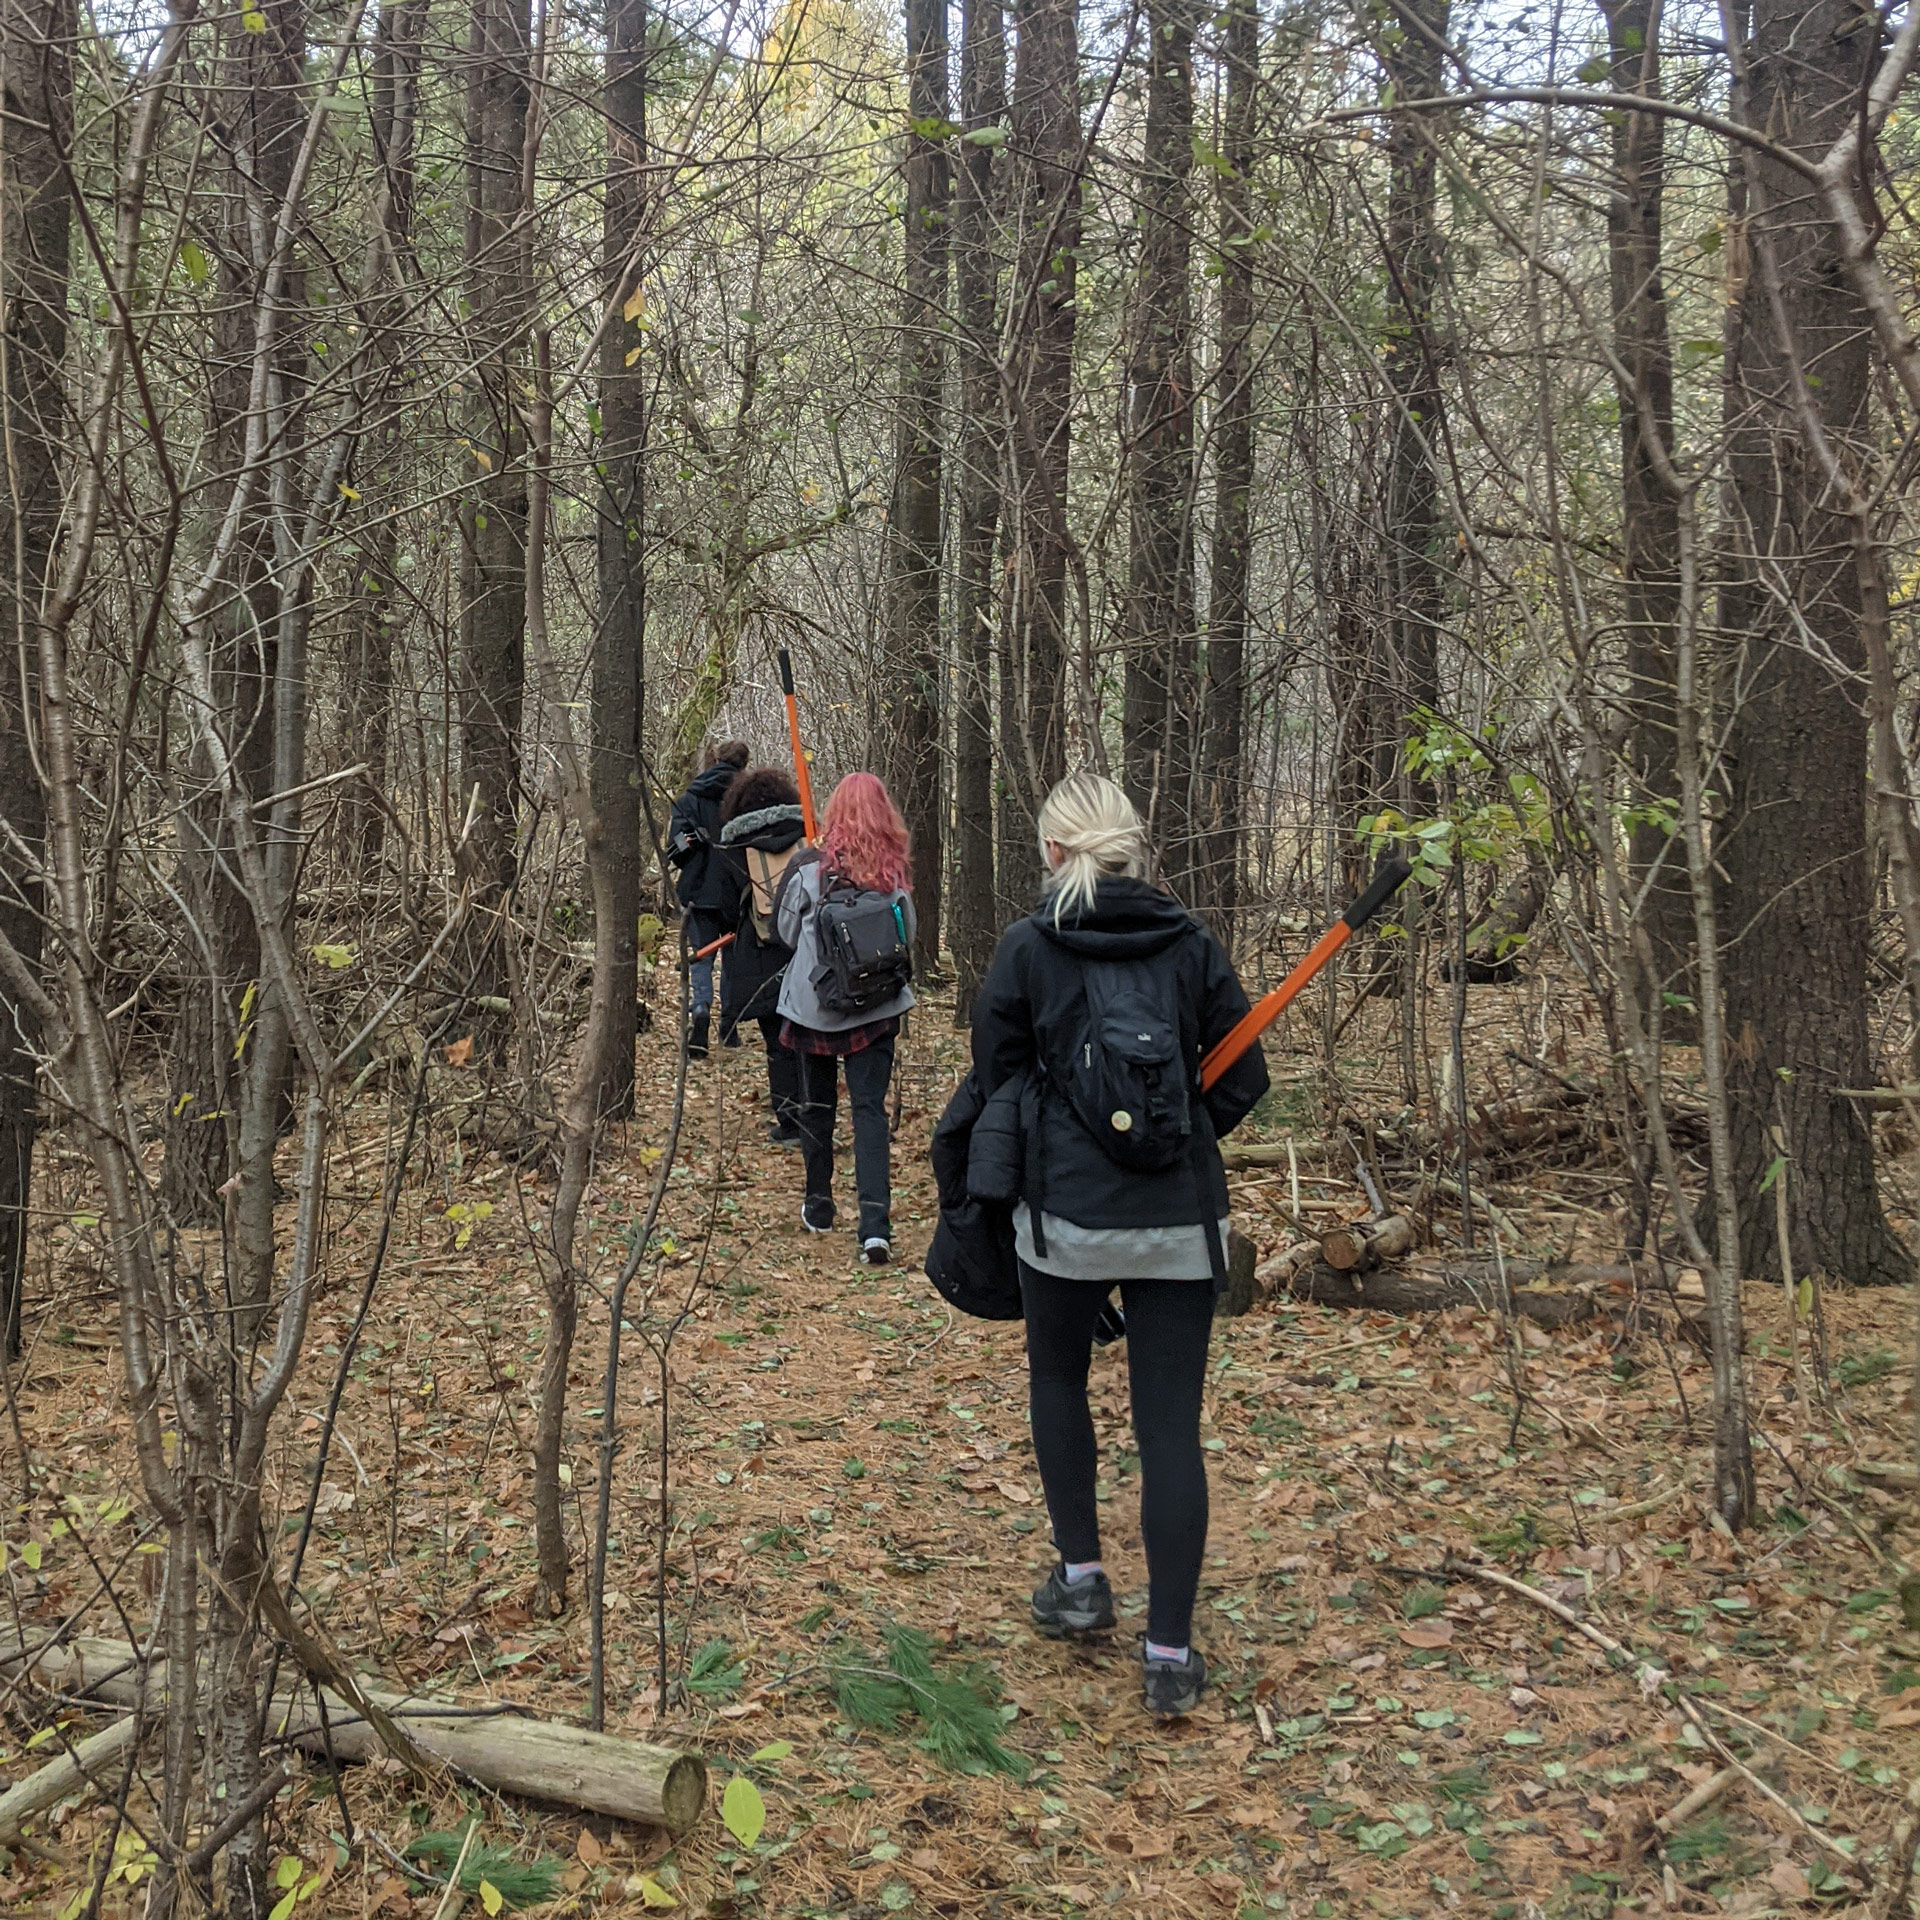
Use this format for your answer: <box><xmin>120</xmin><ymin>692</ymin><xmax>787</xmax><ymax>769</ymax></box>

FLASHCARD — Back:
<box><xmin>1048</xmin><ymin>960</ymin><xmax>1194</xmax><ymax>1173</ymax></box>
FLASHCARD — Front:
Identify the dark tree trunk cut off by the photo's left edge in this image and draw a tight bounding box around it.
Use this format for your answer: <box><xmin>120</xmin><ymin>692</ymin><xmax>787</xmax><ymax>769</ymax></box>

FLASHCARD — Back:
<box><xmin>0</xmin><ymin>0</ymin><xmax>73</xmax><ymax>1354</ymax></box>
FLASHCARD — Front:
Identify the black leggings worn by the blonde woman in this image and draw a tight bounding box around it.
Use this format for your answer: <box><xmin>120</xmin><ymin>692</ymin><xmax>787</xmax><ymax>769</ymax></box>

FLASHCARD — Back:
<box><xmin>1020</xmin><ymin>1261</ymin><xmax>1213</xmax><ymax>1647</ymax></box>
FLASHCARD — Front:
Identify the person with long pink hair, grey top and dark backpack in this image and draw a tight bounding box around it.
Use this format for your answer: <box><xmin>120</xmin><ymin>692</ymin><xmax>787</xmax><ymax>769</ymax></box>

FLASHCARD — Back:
<box><xmin>776</xmin><ymin>774</ymin><xmax>914</xmax><ymax>1267</ymax></box>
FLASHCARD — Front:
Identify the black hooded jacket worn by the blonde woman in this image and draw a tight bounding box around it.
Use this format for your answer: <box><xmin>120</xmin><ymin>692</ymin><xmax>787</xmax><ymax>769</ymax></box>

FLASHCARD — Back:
<box><xmin>973</xmin><ymin>877</ymin><xmax>1267</xmax><ymax>1227</ymax></box>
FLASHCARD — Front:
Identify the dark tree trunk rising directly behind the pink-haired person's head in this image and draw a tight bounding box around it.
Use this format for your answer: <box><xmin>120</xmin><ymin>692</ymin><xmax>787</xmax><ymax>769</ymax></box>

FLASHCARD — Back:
<box><xmin>887</xmin><ymin>0</ymin><xmax>950</xmax><ymax>970</ymax></box>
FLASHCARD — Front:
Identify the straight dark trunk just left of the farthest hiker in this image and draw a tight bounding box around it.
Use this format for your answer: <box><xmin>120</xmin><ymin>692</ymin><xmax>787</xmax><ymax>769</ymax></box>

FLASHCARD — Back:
<box><xmin>588</xmin><ymin>0</ymin><xmax>649</xmax><ymax>1116</ymax></box>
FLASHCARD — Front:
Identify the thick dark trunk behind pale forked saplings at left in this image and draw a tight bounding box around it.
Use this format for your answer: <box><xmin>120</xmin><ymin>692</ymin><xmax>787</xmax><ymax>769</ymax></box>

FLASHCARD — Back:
<box><xmin>161</xmin><ymin>0</ymin><xmax>307</xmax><ymax>1221</ymax></box>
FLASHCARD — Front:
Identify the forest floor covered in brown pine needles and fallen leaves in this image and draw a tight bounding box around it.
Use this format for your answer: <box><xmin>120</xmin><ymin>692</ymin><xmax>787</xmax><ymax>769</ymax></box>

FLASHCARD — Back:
<box><xmin>0</xmin><ymin>952</ymin><xmax>1920</xmax><ymax>1920</ymax></box>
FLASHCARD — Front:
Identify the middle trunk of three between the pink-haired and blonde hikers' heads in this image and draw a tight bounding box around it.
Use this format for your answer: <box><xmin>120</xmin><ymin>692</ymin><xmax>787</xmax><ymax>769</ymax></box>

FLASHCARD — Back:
<box><xmin>947</xmin><ymin>0</ymin><xmax>1006</xmax><ymax>1020</ymax></box>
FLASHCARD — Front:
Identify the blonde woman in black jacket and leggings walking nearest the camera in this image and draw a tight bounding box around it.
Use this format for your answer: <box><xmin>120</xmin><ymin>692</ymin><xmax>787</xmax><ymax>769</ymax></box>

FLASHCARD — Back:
<box><xmin>973</xmin><ymin>774</ymin><xmax>1267</xmax><ymax>1718</ymax></box>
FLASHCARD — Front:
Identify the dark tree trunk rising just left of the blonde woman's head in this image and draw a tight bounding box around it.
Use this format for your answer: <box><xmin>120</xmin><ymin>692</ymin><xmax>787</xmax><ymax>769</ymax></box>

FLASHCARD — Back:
<box><xmin>998</xmin><ymin>0</ymin><xmax>1081</xmax><ymax>910</ymax></box>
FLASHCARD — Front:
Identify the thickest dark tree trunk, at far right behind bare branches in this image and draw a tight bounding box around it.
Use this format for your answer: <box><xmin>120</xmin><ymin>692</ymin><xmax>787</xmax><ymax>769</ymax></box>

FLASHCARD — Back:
<box><xmin>1713</xmin><ymin>0</ymin><xmax>1910</xmax><ymax>1284</ymax></box>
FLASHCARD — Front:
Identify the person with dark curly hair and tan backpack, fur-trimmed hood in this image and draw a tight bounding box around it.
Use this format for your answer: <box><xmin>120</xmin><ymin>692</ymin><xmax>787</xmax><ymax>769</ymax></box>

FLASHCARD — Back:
<box><xmin>720</xmin><ymin>766</ymin><xmax>806</xmax><ymax>1146</ymax></box>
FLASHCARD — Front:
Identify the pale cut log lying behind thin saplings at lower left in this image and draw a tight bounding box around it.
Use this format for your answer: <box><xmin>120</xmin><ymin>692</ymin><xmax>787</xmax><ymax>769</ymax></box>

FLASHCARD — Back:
<box><xmin>0</xmin><ymin>1636</ymin><xmax>707</xmax><ymax>1834</ymax></box>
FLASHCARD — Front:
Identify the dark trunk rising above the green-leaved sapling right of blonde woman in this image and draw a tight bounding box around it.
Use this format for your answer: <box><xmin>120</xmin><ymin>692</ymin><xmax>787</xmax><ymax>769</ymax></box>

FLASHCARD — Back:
<box><xmin>1386</xmin><ymin>0</ymin><xmax>1448</xmax><ymax>733</ymax></box>
